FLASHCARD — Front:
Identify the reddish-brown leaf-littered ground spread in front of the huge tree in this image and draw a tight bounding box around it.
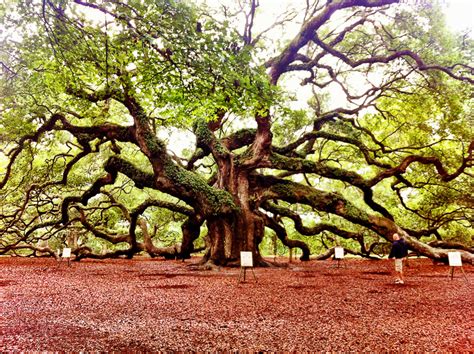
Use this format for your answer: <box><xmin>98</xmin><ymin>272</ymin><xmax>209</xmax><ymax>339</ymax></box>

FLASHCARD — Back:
<box><xmin>0</xmin><ymin>258</ymin><xmax>474</xmax><ymax>352</ymax></box>
